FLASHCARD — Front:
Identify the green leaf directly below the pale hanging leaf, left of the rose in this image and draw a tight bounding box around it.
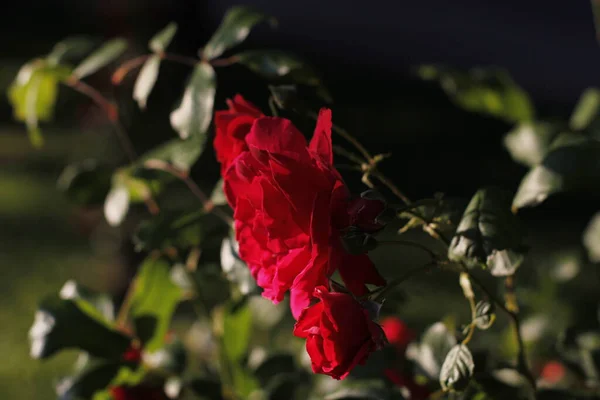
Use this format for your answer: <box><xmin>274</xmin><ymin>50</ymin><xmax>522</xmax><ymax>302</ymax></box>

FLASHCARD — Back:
<box><xmin>138</xmin><ymin>135</ymin><xmax>206</xmax><ymax>172</ymax></box>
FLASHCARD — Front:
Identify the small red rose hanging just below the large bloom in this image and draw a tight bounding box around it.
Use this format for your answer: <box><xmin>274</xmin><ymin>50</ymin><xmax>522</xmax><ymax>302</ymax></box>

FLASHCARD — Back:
<box><xmin>294</xmin><ymin>286</ymin><xmax>385</xmax><ymax>379</ymax></box>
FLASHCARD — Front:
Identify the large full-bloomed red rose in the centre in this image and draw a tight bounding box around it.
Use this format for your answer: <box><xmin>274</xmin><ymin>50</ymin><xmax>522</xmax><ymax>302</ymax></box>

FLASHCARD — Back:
<box><xmin>224</xmin><ymin>110</ymin><xmax>385</xmax><ymax>317</ymax></box>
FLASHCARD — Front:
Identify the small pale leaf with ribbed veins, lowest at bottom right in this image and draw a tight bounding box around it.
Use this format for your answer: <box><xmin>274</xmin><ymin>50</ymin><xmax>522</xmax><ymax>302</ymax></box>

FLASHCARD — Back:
<box><xmin>440</xmin><ymin>344</ymin><xmax>475</xmax><ymax>391</ymax></box>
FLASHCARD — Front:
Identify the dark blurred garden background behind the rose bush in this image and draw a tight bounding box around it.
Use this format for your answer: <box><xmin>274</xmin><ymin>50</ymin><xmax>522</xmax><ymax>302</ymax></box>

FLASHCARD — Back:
<box><xmin>0</xmin><ymin>0</ymin><xmax>600</xmax><ymax>399</ymax></box>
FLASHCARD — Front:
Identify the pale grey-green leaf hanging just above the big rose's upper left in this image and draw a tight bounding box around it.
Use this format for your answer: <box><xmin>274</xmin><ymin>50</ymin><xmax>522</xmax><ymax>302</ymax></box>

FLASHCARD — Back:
<box><xmin>171</xmin><ymin>62</ymin><xmax>216</xmax><ymax>139</ymax></box>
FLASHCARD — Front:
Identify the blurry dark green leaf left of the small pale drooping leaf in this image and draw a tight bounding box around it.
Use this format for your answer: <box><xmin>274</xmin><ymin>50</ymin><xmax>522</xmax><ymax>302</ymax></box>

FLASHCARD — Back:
<box><xmin>57</xmin><ymin>159</ymin><xmax>112</xmax><ymax>206</ymax></box>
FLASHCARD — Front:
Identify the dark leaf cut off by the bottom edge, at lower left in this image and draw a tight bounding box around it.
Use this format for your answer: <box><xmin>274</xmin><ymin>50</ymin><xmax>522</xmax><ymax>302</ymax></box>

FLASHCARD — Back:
<box><xmin>56</xmin><ymin>362</ymin><xmax>123</xmax><ymax>400</ymax></box>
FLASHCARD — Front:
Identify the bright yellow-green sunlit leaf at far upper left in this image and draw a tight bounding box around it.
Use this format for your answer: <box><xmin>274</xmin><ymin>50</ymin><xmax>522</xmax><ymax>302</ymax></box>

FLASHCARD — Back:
<box><xmin>8</xmin><ymin>60</ymin><xmax>70</xmax><ymax>147</ymax></box>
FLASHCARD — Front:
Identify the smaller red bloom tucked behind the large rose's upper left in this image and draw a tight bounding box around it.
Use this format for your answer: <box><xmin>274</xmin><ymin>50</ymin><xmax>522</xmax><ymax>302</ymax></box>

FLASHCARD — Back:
<box><xmin>214</xmin><ymin>94</ymin><xmax>263</xmax><ymax>175</ymax></box>
